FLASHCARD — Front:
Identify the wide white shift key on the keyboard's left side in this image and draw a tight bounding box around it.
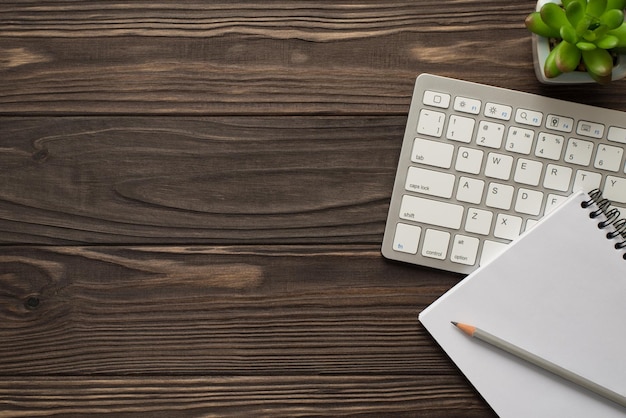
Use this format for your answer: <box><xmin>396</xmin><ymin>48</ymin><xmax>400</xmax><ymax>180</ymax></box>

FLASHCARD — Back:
<box><xmin>400</xmin><ymin>195</ymin><xmax>463</xmax><ymax>229</ymax></box>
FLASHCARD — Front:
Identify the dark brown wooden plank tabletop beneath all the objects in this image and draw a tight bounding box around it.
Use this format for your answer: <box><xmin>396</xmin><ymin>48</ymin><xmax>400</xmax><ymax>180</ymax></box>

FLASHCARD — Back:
<box><xmin>0</xmin><ymin>0</ymin><xmax>626</xmax><ymax>417</ymax></box>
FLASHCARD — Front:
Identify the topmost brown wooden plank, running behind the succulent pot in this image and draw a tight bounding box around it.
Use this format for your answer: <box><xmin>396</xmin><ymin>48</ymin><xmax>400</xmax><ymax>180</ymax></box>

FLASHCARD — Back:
<box><xmin>6</xmin><ymin>0</ymin><xmax>626</xmax><ymax>115</ymax></box>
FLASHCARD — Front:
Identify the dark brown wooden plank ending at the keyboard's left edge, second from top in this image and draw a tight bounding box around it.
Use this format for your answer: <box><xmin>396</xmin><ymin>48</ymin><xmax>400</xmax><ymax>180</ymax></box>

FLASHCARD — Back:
<box><xmin>0</xmin><ymin>117</ymin><xmax>406</xmax><ymax>244</ymax></box>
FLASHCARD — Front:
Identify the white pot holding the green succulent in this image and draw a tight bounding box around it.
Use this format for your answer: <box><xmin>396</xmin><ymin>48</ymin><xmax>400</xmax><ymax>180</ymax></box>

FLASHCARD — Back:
<box><xmin>532</xmin><ymin>0</ymin><xmax>626</xmax><ymax>84</ymax></box>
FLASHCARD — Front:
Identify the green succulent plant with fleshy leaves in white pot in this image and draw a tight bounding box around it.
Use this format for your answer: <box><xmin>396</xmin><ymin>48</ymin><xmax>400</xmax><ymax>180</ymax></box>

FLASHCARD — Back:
<box><xmin>525</xmin><ymin>0</ymin><xmax>626</xmax><ymax>84</ymax></box>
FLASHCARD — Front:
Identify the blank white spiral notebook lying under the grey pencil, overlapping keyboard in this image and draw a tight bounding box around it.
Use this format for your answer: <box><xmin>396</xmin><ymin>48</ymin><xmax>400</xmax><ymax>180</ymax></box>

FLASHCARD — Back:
<box><xmin>419</xmin><ymin>192</ymin><xmax>626</xmax><ymax>418</ymax></box>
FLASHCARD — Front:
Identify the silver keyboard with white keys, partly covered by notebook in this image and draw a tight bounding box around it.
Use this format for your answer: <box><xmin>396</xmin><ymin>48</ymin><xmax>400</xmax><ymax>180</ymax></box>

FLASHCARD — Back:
<box><xmin>382</xmin><ymin>74</ymin><xmax>626</xmax><ymax>274</ymax></box>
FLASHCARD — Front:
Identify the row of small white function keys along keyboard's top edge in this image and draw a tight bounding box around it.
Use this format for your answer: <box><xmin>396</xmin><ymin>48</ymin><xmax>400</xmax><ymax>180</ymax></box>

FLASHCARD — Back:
<box><xmin>422</xmin><ymin>90</ymin><xmax>626</xmax><ymax>144</ymax></box>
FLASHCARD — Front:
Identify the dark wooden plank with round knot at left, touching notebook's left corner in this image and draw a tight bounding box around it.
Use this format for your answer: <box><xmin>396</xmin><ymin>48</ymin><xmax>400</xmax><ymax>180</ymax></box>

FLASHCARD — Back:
<box><xmin>0</xmin><ymin>246</ymin><xmax>460</xmax><ymax>380</ymax></box>
